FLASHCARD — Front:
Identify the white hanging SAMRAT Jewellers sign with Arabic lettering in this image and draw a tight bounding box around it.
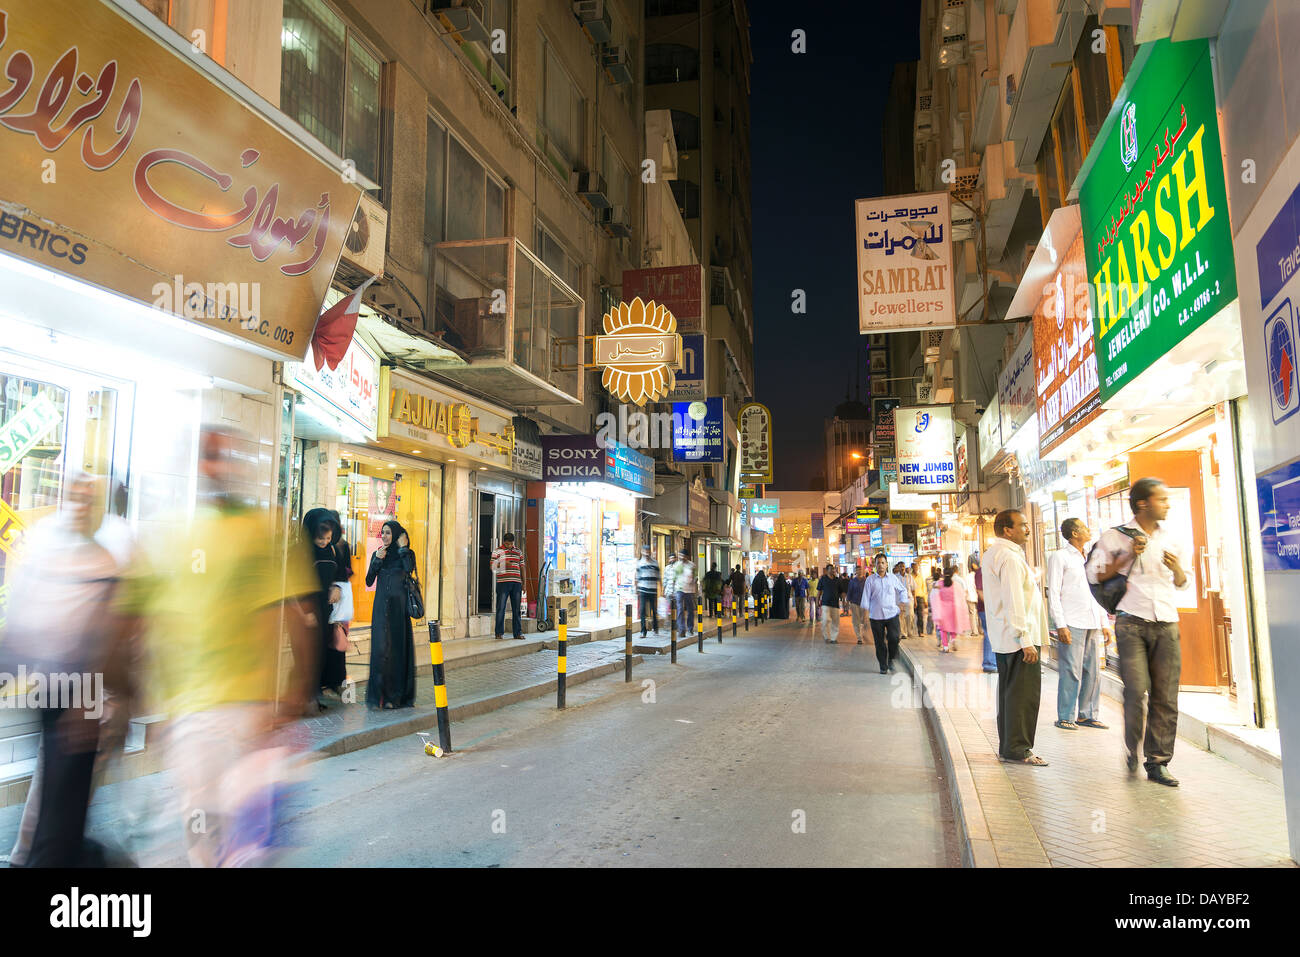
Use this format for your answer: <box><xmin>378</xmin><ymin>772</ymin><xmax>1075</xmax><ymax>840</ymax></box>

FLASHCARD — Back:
<box><xmin>854</xmin><ymin>192</ymin><xmax>957</xmax><ymax>334</ymax></box>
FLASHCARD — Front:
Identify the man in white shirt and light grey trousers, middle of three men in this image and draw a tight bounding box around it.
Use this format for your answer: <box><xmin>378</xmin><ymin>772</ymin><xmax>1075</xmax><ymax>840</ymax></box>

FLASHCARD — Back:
<box><xmin>1048</xmin><ymin>519</ymin><xmax>1109</xmax><ymax>731</ymax></box>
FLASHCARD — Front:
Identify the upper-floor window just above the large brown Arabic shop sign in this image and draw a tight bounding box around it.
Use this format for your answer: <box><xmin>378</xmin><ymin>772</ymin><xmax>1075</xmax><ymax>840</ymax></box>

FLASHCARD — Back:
<box><xmin>280</xmin><ymin>0</ymin><xmax>381</xmax><ymax>181</ymax></box>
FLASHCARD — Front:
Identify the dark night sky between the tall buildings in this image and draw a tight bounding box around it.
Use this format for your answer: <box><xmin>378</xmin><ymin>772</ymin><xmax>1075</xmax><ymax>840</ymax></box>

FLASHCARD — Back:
<box><xmin>749</xmin><ymin>0</ymin><xmax>920</xmax><ymax>489</ymax></box>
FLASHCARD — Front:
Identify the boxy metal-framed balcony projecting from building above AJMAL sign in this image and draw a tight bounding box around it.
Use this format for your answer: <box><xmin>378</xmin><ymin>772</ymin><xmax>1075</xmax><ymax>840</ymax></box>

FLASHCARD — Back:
<box><xmin>436</xmin><ymin>237</ymin><xmax>585</xmax><ymax>404</ymax></box>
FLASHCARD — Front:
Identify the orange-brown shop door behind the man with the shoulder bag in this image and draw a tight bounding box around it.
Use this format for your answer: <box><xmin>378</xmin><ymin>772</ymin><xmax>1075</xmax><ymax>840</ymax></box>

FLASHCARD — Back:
<box><xmin>1128</xmin><ymin>451</ymin><xmax>1232</xmax><ymax>690</ymax></box>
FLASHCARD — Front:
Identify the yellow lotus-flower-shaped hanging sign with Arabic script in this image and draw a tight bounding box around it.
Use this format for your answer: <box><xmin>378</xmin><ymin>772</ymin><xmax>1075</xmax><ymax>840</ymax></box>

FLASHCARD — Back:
<box><xmin>593</xmin><ymin>296</ymin><xmax>681</xmax><ymax>406</ymax></box>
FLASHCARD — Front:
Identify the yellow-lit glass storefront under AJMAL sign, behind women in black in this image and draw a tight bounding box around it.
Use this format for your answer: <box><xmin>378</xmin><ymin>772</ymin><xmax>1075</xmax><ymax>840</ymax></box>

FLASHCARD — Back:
<box><xmin>334</xmin><ymin>446</ymin><xmax>442</xmax><ymax>625</ymax></box>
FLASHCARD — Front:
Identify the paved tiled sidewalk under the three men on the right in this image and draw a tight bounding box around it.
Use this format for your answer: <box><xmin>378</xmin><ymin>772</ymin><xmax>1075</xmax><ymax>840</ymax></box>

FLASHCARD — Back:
<box><xmin>901</xmin><ymin>637</ymin><xmax>1294</xmax><ymax>867</ymax></box>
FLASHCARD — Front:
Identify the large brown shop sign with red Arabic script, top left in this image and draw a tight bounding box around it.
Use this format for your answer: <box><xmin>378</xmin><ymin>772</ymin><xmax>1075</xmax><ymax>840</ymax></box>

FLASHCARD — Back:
<box><xmin>0</xmin><ymin>0</ymin><xmax>360</xmax><ymax>360</ymax></box>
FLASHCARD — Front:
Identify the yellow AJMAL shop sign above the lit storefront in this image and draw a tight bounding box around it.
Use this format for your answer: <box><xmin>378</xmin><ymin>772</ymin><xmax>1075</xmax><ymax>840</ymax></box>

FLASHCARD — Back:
<box><xmin>378</xmin><ymin>368</ymin><xmax>515</xmax><ymax>471</ymax></box>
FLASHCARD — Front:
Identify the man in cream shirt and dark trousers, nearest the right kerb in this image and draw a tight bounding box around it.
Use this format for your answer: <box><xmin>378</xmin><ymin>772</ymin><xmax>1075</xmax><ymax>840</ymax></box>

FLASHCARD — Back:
<box><xmin>980</xmin><ymin>508</ymin><xmax>1048</xmax><ymax>767</ymax></box>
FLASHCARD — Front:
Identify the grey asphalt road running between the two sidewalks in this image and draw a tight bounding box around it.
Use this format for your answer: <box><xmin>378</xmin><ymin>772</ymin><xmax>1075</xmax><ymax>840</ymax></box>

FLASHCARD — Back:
<box><xmin>283</xmin><ymin>619</ymin><xmax>959</xmax><ymax>867</ymax></box>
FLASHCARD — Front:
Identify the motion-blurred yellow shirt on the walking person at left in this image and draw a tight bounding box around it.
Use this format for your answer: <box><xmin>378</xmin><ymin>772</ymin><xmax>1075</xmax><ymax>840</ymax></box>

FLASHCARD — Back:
<box><xmin>124</xmin><ymin>506</ymin><xmax>320</xmax><ymax>714</ymax></box>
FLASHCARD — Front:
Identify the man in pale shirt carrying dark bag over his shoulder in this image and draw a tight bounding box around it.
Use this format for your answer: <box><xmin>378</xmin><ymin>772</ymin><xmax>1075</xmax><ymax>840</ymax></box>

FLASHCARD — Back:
<box><xmin>1088</xmin><ymin>479</ymin><xmax>1187</xmax><ymax>788</ymax></box>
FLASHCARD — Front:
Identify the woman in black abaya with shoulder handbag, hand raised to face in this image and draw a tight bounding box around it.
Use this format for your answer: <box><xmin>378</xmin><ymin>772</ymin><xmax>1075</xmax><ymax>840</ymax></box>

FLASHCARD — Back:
<box><xmin>365</xmin><ymin>521</ymin><xmax>415</xmax><ymax>709</ymax></box>
